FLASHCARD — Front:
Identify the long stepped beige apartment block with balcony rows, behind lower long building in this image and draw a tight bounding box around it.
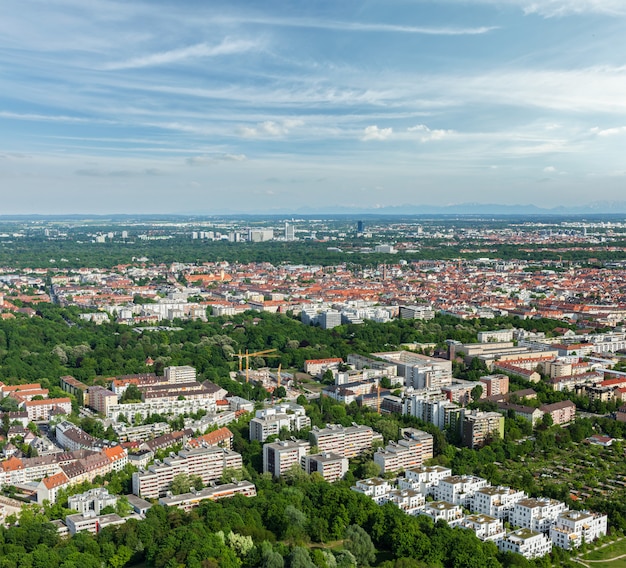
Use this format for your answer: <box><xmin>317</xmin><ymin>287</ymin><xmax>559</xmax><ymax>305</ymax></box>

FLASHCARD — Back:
<box><xmin>133</xmin><ymin>448</ymin><xmax>242</xmax><ymax>499</ymax></box>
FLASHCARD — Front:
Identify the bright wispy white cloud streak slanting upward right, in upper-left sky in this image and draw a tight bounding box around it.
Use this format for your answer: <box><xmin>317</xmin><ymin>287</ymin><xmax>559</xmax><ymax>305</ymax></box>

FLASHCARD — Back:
<box><xmin>103</xmin><ymin>38</ymin><xmax>260</xmax><ymax>71</ymax></box>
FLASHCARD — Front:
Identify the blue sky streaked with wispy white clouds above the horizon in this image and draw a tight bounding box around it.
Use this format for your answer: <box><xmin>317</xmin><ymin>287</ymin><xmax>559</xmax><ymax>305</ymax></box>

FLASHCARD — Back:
<box><xmin>0</xmin><ymin>0</ymin><xmax>626</xmax><ymax>214</ymax></box>
